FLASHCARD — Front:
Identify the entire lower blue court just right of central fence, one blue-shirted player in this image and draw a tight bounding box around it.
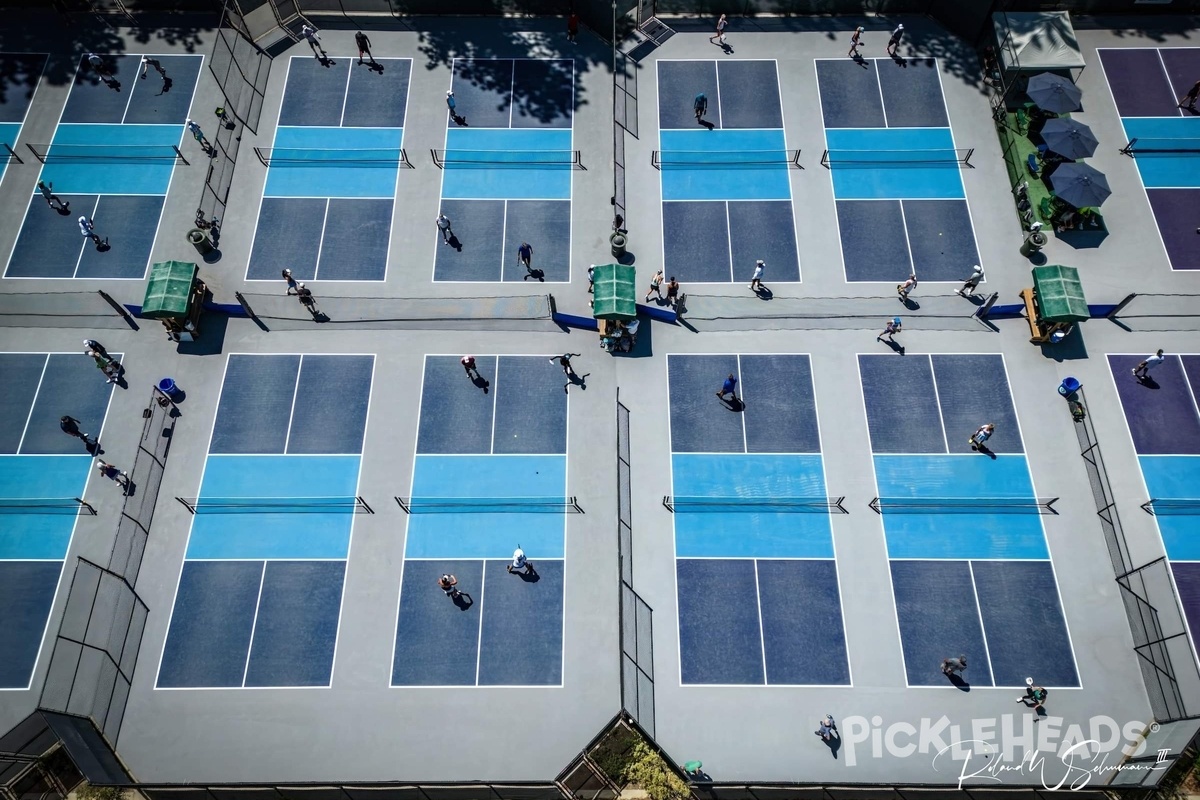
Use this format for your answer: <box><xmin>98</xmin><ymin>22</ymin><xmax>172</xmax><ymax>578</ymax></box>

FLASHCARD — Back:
<box><xmin>667</xmin><ymin>355</ymin><xmax>851</xmax><ymax>686</ymax></box>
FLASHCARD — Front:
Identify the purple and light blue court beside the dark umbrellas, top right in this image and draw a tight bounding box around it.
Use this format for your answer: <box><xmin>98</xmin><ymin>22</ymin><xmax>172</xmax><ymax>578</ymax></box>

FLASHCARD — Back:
<box><xmin>1097</xmin><ymin>47</ymin><xmax>1200</xmax><ymax>270</ymax></box>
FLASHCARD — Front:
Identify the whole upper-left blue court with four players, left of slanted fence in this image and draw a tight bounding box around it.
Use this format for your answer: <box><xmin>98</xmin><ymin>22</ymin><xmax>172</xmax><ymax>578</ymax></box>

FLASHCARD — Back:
<box><xmin>5</xmin><ymin>53</ymin><xmax>201</xmax><ymax>279</ymax></box>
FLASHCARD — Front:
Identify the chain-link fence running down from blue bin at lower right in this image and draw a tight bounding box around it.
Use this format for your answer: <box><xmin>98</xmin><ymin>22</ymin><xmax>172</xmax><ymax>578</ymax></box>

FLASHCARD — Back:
<box><xmin>1074</xmin><ymin>389</ymin><xmax>1200</xmax><ymax>723</ymax></box>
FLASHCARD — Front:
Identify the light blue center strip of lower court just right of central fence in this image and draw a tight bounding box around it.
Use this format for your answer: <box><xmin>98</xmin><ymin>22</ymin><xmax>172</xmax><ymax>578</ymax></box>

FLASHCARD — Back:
<box><xmin>671</xmin><ymin>453</ymin><xmax>833</xmax><ymax>559</ymax></box>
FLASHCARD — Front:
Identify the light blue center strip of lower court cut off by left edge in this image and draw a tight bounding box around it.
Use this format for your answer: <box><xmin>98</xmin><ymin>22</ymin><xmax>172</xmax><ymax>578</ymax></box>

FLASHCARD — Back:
<box><xmin>0</xmin><ymin>455</ymin><xmax>91</xmax><ymax>559</ymax></box>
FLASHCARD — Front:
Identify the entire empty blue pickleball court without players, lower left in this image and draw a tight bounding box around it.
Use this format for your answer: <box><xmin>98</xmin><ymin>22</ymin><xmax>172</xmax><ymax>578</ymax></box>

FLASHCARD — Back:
<box><xmin>157</xmin><ymin>355</ymin><xmax>374</xmax><ymax>688</ymax></box>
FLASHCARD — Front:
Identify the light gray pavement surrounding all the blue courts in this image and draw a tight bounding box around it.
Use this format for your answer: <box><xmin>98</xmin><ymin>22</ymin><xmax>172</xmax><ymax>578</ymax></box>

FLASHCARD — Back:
<box><xmin>0</xmin><ymin>6</ymin><xmax>1200</xmax><ymax>786</ymax></box>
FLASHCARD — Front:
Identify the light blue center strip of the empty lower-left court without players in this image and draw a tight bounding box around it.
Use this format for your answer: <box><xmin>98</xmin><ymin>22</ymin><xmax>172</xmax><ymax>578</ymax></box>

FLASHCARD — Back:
<box><xmin>187</xmin><ymin>456</ymin><xmax>360</xmax><ymax>560</ymax></box>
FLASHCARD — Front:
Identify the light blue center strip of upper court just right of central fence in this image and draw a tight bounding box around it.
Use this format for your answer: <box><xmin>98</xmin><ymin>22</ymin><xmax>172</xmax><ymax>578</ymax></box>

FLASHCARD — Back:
<box><xmin>659</xmin><ymin>130</ymin><xmax>792</xmax><ymax>200</ymax></box>
